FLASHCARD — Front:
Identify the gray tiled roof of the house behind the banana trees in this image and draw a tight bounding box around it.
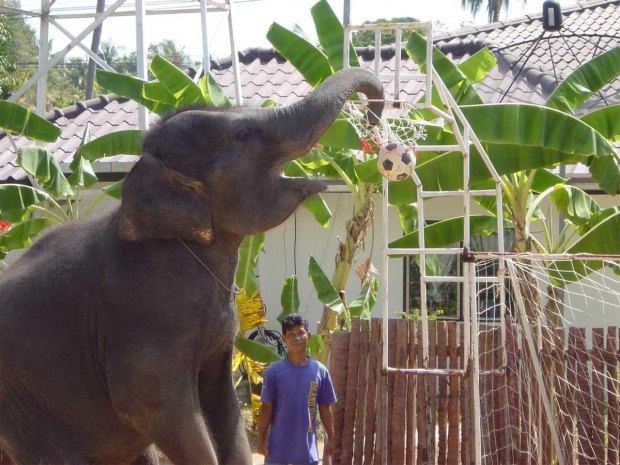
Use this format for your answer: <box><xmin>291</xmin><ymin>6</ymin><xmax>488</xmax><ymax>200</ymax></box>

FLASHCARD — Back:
<box><xmin>0</xmin><ymin>0</ymin><xmax>620</xmax><ymax>182</ymax></box>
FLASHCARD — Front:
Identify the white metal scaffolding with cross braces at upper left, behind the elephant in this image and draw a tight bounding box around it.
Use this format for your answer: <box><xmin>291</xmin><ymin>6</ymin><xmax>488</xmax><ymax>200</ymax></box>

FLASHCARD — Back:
<box><xmin>0</xmin><ymin>0</ymin><xmax>243</xmax><ymax>129</ymax></box>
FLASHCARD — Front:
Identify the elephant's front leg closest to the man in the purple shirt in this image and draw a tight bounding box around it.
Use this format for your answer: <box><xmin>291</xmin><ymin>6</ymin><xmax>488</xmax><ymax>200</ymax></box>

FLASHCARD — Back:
<box><xmin>198</xmin><ymin>352</ymin><xmax>252</xmax><ymax>465</ymax></box>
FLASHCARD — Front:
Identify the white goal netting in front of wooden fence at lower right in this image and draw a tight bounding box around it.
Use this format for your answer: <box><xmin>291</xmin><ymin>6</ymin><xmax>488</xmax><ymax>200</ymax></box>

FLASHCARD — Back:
<box><xmin>475</xmin><ymin>257</ymin><xmax>620</xmax><ymax>465</ymax></box>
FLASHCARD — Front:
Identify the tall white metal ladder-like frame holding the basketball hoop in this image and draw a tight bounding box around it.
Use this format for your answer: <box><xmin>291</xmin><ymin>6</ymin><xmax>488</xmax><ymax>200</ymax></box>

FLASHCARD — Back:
<box><xmin>343</xmin><ymin>16</ymin><xmax>506</xmax><ymax>464</ymax></box>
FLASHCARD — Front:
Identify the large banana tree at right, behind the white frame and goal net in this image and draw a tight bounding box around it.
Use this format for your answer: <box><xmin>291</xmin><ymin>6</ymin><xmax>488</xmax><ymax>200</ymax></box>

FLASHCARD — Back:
<box><xmin>393</xmin><ymin>37</ymin><xmax>620</xmax><ymax>324</ymax></box>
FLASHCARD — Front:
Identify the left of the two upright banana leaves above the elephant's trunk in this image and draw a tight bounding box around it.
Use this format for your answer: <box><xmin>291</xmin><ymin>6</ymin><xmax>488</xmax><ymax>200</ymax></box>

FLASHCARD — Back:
<box><xmin>267</xmin><ymin>23</ymin><xmax>334</xmax><ymax>87</ymax></box>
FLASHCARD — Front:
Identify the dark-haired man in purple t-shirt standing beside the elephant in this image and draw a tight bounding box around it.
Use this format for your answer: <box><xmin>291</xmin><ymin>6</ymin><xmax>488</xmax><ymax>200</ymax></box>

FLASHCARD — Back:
<box><xmin>258</xmin><ymin>313</ymin><xmax>336</xmax><ymax>465</ymax></box>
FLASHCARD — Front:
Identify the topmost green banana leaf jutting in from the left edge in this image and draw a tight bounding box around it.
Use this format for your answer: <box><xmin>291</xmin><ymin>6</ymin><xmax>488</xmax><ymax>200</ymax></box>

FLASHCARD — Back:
<box><xmin>0</xmin><ymin>100</ymin><xmax>61</xmax><ymax>142</ymax></box>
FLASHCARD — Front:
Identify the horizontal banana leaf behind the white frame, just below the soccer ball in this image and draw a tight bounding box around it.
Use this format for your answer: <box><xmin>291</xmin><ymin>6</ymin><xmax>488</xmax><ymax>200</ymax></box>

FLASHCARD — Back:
<box><xmin>388</xmin><ymin>215</ymin><xmax>510</xmax><ymax>249</ymax></box>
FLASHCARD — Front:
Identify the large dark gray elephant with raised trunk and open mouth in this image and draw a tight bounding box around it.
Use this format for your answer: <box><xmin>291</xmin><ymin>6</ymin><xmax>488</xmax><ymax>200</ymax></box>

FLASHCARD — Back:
<box><xmin>0</xmin><ymin>69</ymin><xmax>383</xmax><ymax>465</ymax></box>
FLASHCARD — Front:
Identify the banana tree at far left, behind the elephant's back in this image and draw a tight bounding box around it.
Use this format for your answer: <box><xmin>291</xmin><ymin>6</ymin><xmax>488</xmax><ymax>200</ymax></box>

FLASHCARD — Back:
<box><xmin>0</xmin><ymin>101</ymin><xmax>139</xmax><ymax>258</ymax></box>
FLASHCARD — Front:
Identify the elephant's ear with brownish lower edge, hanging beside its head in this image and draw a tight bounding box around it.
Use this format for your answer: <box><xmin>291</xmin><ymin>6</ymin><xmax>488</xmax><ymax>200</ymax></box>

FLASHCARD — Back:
<box><xmin>118</xmin><ymin>155</ymin><xmax>213</xmax><ymax>244</ymax></box>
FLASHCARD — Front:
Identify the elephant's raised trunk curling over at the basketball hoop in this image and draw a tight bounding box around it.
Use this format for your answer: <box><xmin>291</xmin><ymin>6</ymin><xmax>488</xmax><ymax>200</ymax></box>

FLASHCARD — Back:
<box><xmin>274</xmin><ymin>68</ymin><xmax>383</xmax><ymax>161</ymax></box>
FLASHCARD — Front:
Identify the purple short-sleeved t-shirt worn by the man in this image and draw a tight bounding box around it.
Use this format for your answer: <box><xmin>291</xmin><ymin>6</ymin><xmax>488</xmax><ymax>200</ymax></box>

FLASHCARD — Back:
<box><xmin>260</xmin><ymin>358</ymin><xmax>336</xmax><ymax>463</ymax></box>
